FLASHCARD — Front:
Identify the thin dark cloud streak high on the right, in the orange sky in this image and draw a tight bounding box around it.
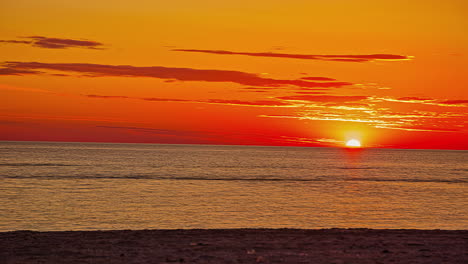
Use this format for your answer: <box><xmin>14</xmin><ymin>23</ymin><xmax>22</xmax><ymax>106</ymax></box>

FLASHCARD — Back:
<box><xmin>172</xmin><ymin>49</ymin><xmax>412</xmax><ymax>62</ymax></box>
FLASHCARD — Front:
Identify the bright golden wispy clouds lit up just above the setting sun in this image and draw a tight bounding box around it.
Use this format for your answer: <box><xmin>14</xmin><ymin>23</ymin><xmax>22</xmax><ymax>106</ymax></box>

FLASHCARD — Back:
<box><xmin>260</xmin><ymin>96</ymin><xmax>466</xmax><ymax>132</ymax></box>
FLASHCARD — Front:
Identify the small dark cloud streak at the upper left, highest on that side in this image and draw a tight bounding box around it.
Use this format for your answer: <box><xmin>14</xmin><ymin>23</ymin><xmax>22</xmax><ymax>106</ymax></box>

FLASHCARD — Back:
<box><xmin>0</xmin><ymin>36</ymin><xmax>103</xmax><ymax>49</ymax></box>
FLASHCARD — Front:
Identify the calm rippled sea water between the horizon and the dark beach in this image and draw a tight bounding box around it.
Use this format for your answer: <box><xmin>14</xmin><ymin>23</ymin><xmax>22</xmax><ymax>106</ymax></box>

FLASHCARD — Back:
<box><xmin>0</xmin><ymin>142</ymin><xmax>468</xmax><ymax>231</ymax></box>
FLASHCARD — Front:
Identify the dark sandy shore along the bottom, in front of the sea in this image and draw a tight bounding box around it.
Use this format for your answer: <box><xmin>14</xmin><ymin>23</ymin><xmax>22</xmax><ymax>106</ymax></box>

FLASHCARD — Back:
<box><xmin>0</xmin><ymin>229</ymin><xmax>468</xmax><ymax>264</ymax></box>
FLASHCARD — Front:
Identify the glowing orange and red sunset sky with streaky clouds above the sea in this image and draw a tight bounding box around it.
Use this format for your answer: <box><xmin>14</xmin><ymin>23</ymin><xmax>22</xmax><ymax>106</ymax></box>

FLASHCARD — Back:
<box><xmin>0</xmin><ymin>0</ymin><xmax>468</xmax><ymax>150</ymax></box>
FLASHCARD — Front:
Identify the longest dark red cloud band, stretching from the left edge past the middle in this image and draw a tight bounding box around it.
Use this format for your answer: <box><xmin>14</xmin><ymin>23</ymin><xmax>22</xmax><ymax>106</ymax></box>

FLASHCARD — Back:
<box><xmin>0</xmin><ymin>62</ymin><xmax>351</xmax><ymax>88</ymax></box>
